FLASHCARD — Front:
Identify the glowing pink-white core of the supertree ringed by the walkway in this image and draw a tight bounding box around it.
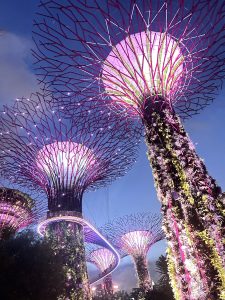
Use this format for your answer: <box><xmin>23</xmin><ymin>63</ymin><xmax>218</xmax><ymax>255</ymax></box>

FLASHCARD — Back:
<box><xmin>36</xmin><ymin>141</ymin><xmax>96</xmax><ymax>187</ymax></box>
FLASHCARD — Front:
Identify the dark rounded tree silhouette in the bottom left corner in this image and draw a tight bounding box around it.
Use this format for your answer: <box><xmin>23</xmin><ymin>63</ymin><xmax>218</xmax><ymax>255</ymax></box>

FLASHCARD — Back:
<box><xmin>0</xmin><ymin>231</ymin><xmax>64</xmax><ymax>300</ymax></box>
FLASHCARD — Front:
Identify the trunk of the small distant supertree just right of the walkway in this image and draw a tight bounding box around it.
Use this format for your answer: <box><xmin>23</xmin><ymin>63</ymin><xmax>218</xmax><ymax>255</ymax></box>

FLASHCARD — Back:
<box><xmin>133</xmin><ymin>255</ymin><xmax>152</xmax><ymax>296</ymax></box>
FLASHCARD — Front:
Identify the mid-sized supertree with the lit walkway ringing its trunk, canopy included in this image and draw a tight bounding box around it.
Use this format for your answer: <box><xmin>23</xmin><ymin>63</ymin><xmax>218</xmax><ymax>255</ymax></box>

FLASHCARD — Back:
<box><xmin>0</xmin><ymin>93</ymin><xmax>137</xmax><ymax>299</ymax></box>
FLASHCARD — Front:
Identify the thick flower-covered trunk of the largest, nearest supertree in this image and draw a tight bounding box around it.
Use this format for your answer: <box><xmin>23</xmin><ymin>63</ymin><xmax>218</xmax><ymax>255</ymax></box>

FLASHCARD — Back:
<box><xmin>145</xmin><ymin>107</ymin><xmax>225</xmax><ymax>300</ymax></box>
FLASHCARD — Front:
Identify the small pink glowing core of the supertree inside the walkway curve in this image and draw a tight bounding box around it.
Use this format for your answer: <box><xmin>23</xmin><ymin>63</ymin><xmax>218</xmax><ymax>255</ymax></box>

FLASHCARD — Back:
<box><xmin>88</xmin><ymin>248</ymin><xmax>116</xmax><ymax>273</ymax></box>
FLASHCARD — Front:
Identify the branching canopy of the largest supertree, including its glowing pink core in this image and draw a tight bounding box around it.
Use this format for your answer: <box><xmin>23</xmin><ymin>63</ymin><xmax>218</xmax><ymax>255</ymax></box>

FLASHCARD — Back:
<box><xmin>33</xmin><ymin>0</ymin><xmax>224</xmax><ymax>117</ymax></box>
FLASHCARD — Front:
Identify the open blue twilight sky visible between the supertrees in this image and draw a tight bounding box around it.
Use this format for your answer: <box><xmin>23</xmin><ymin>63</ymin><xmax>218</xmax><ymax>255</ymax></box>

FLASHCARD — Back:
<box><xmin>0</xmin><ymin>0</ymin><xmax>225</xmax><ymax>288</ymax></box>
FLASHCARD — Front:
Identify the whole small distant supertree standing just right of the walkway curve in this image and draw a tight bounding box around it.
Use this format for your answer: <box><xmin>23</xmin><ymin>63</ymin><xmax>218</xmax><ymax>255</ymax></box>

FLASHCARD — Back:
<box><xmin>101</xmin><ymin>213</ymin><xmax>164</xmax><ymax>297</ymax></box>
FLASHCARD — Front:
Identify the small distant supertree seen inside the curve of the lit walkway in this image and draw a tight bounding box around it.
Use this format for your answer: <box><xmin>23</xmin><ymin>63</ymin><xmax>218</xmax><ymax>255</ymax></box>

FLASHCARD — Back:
<box><xmin>86</xmin><ymin>244</ymin><xmax>116</xmax><ymax>299</ymax></box>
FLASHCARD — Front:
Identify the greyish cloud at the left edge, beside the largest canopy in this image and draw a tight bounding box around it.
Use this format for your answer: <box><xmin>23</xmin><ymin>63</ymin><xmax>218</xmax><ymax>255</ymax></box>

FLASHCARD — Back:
<box><xmin>0</xmin><ymin>31</ymin><xmax>38</xmax><ymax>104</ymax></box>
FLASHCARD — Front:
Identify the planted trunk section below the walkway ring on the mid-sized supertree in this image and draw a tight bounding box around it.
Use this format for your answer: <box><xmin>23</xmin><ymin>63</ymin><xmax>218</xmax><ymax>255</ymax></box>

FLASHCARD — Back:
<box><xmin>47</xmin><ymin>217</ymin><xmax>91</xmax><ymax>300</ymax></box>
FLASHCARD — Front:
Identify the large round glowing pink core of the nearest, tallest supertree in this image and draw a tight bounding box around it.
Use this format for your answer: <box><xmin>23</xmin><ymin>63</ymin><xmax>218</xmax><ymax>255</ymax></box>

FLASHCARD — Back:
<box><xmin>102</xmin><ymin>31</ymin><xmax>185</xmax><ymax>107</ymax></box>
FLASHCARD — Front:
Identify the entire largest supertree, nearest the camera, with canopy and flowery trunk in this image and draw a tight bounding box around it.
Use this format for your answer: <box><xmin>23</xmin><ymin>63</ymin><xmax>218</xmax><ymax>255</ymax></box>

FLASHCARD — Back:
<box><xmin>34</xmin><ymin>0</ymin><xmax>225</xmax><ymax>299</ymax></box>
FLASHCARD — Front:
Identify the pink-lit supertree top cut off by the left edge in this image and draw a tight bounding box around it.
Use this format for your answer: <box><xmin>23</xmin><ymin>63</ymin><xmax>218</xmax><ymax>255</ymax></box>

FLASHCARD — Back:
<box><xmin>0</xmin><ymin>187</ymin><xmax>36</xmax><ymax>238</ymax></box>
